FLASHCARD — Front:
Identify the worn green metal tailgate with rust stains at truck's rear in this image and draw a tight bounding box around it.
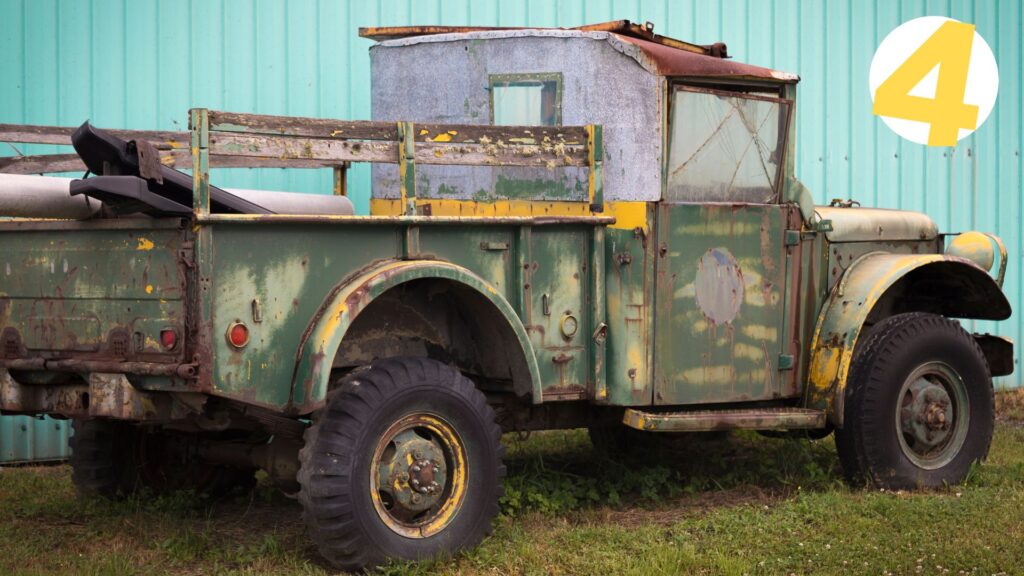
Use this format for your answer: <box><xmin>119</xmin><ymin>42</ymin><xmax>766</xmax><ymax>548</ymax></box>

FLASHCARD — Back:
<box><xmin>0</xmin><ymin>218</ymin><xmax>187</xmax><ymax>363</ymax></box>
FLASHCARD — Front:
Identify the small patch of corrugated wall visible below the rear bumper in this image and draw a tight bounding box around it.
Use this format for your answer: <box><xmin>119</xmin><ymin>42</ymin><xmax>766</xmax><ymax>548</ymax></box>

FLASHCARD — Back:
<box><xmin>0</xmin><ymin>416</ymin><xmax>72</xmax><ymax>464</ymax></box>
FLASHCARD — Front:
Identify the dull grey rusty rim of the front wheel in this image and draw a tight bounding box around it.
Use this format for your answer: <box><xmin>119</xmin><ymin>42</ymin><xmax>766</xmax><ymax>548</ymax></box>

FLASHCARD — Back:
<box><xmin>896</xmin><ymin>362</ymin><xmax>971</xmax><ymax>469</ymax></box>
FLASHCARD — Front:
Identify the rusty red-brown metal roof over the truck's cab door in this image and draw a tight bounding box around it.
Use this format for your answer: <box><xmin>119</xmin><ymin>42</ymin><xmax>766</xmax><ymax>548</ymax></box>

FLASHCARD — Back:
<box><xmin>610</xmin><ymin>34</ymin><xmax>800</xmax><ymax>83</ymax></box>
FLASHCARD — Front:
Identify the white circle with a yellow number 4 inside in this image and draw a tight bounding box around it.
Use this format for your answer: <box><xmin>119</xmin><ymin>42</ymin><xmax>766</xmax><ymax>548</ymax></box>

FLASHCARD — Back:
<box><xmin>867</xmin><ymin>16</ymin><xmax>999</xmax><ymax>146</ymax></box>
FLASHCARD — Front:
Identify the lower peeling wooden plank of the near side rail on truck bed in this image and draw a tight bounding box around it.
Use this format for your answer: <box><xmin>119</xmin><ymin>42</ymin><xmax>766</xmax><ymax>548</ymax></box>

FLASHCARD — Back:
<box><xmin>210</xmin><ymin>132</ymin><xmax>587</xmax><ymax>168</ymax></box>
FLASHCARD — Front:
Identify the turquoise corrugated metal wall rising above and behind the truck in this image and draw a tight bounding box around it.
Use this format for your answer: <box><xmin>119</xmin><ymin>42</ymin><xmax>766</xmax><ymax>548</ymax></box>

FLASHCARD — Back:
<box><xmin>0</xmin><ymin>0</ymin><xmax>1024</xmax><ymax>384</ymax></box>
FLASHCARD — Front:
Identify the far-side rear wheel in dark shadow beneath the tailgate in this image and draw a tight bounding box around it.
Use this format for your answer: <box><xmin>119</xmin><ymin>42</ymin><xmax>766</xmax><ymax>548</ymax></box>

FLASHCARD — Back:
<box><xmin>71</xmin><ymin>420</ymin><xmax>256</xmax><ymax>498</ymax></box>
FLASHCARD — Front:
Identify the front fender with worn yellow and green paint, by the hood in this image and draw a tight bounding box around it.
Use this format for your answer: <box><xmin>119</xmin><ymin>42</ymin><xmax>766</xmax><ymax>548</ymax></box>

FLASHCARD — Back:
<box><xmin>806</xmin><ymin>253</ymin><xmax>1011</xmax><ymax>427</ymax></box>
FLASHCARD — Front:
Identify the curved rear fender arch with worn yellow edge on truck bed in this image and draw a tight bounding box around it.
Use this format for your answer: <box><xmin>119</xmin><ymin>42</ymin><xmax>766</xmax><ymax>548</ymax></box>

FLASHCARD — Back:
<box><xmin>291</xmin><ymin>260</ymin><xmax>542</xmax><ymax>414</ymax></box>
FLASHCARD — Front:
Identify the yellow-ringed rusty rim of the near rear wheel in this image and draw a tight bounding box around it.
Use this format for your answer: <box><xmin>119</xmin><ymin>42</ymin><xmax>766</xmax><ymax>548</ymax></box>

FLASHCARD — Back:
<box><xmin>370</xmin><ymin>413</ymin><xmax>467</xmax><ymax>538</ymax></box>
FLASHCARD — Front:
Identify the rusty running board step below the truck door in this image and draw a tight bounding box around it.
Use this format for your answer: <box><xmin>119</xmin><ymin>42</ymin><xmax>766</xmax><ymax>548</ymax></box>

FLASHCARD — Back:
<box><xmin>623</xmin><ymin>408</ymin><xmax>825</xmax><ymax>431</ymax></box>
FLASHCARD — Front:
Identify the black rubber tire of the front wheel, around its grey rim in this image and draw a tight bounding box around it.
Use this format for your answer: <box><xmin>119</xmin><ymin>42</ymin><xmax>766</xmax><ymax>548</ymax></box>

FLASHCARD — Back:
<box><xmin>836</xmin><ymin>313</ymin><xmax>995</xmax><ymax>490</ymax></box>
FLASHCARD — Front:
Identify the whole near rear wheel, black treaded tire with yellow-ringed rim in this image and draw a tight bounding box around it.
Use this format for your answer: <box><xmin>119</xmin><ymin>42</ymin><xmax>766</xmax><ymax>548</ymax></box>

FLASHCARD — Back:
<box><xmin>299</xmin><ymin>358</ymin><xmax>505</xmax><ymax>570</ymax></box>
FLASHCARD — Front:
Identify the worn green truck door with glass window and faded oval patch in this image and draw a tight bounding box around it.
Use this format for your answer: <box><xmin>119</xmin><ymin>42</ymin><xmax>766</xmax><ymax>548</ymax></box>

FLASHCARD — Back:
<box><xmin>653</xmin><ymin>87</ymin><xmax>800</xmax><ymax>405</ymax></box>
